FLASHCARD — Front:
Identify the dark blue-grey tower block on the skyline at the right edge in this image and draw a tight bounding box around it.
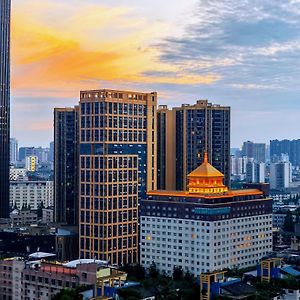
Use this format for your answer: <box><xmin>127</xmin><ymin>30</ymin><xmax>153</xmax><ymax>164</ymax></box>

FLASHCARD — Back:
<box><xmin>270</xmin><ymin>139</ymin><xmax>300</xmax><ymax>166</ymax></box>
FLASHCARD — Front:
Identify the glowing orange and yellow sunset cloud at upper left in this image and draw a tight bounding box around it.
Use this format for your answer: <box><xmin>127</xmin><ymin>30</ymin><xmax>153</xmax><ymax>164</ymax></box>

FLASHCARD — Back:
<box><xmin>12</xmin><ymin>0</ymin><xmax>220</xmax><ymax>96</ymax></box>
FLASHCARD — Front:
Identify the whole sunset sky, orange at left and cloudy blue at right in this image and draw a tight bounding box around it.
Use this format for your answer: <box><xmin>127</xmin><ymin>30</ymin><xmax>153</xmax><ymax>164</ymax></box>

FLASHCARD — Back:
<box><xmin>11</xmin><ymin>0</ymin><xmax>300</xmax><ymax>147</ymax></box>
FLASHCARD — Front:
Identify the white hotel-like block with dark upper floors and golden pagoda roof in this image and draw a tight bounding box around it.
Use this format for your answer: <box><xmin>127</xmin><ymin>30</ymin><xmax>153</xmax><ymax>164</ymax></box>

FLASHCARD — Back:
<box><xmin>140</xmin><ymin>155</ymin><xmax>272</xmax><ymax>276</ymax></box>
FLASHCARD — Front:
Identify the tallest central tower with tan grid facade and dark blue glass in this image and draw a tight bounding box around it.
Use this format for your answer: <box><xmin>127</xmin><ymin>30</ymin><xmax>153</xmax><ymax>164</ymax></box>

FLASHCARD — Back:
<box><xmin>79</xmin><ymin>90</ymin><xmax>157</xmax><ymax>265</ymax></box>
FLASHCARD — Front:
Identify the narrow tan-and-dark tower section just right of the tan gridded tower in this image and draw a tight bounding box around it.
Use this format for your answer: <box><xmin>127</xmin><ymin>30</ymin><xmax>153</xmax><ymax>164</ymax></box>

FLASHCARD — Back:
<box><xmin>157</xmin><ymin>105</ymin><xmax>176</xmax><ymax>190</ymax></box>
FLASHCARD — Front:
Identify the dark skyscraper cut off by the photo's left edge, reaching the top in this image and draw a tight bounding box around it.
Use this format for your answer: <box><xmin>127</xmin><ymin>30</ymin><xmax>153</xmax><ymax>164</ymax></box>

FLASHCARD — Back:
<box><xmin>0</xmin><ymin>0</ymin><xmax>10</xmax><ymax>218</ymax></box>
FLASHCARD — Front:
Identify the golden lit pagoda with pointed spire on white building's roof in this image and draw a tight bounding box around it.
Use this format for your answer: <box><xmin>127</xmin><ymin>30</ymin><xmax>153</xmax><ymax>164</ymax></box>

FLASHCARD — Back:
<box><xmin>187</xmin><ymin>152</ymin><xmax>228</xmax><ymax>195</ymax></box>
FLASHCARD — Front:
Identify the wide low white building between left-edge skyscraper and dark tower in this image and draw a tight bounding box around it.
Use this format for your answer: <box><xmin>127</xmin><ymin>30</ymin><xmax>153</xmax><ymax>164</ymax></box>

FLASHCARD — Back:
<box><xmin>10</xmin><ymin>181</ymin><xmax>54</xmax><ymax>209</ymax></box>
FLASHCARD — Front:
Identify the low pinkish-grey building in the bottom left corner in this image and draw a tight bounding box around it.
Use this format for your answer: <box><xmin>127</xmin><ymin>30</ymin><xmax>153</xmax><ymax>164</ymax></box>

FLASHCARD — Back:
<box><xmin>0</xmin><ymin>258</ymin><xmax>109</xmax><ymax>300</ymax></box>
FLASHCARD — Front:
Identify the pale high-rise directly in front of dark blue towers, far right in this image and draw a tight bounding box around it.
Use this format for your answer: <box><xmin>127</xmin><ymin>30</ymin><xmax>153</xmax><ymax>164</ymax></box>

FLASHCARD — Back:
<box><xmin>270</xmin><ymin>161</ymin><xmax>292</xmax><ymax>190</ymax></box>
